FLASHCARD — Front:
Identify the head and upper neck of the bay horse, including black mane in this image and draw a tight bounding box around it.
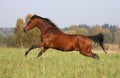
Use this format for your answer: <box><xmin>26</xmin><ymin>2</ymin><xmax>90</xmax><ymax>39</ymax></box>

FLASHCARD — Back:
<box><xmin>23</xmin><ymin>15</ymin><xmax>58</xmax><ymax>33</ymax></box>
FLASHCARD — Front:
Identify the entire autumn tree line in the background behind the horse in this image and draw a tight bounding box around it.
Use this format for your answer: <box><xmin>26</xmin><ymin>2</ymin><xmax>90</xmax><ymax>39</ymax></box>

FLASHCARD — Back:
<box><xmin>0</xmin><ymin>14</ymin><xmax>120</xmax><ymax>47</ymax></box>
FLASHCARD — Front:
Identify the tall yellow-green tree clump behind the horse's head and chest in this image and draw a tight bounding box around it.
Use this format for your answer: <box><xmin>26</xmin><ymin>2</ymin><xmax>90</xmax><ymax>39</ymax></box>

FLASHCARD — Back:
<box><xmin>14</xmin><ymin>14</ymin><xmax>40</xmax><ymax>47</ymax></box>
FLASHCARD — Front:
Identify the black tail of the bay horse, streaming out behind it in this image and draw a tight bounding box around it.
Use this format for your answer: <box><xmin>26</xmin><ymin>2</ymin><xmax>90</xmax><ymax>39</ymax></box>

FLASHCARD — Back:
<box><xmin>88</xmin><ymin>33</ymin><xmax>107</xmax><ymax>53</ymax></box>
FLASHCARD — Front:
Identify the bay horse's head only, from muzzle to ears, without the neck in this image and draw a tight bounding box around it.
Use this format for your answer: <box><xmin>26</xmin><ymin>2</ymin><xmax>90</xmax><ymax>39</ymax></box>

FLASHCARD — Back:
<box><xmin>23</xmin><ymin>15</ymin><xmax>37</xmax><ymax>33</ymax></box>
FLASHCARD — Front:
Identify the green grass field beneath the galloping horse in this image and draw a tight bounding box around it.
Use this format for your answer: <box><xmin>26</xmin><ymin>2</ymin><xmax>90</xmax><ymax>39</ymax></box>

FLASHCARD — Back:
<box><xmin>0</xmin><ymin>48</ymin><xmax>120</xmax><ymax>78</ymax></box>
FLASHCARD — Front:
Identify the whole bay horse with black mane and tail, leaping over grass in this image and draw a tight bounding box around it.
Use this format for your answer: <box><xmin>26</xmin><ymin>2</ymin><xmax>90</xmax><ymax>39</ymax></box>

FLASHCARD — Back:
<box><xmin>23</xmin><ymin>15</ymin><xmax>106</xmax><ymax>59</ymax></box>
